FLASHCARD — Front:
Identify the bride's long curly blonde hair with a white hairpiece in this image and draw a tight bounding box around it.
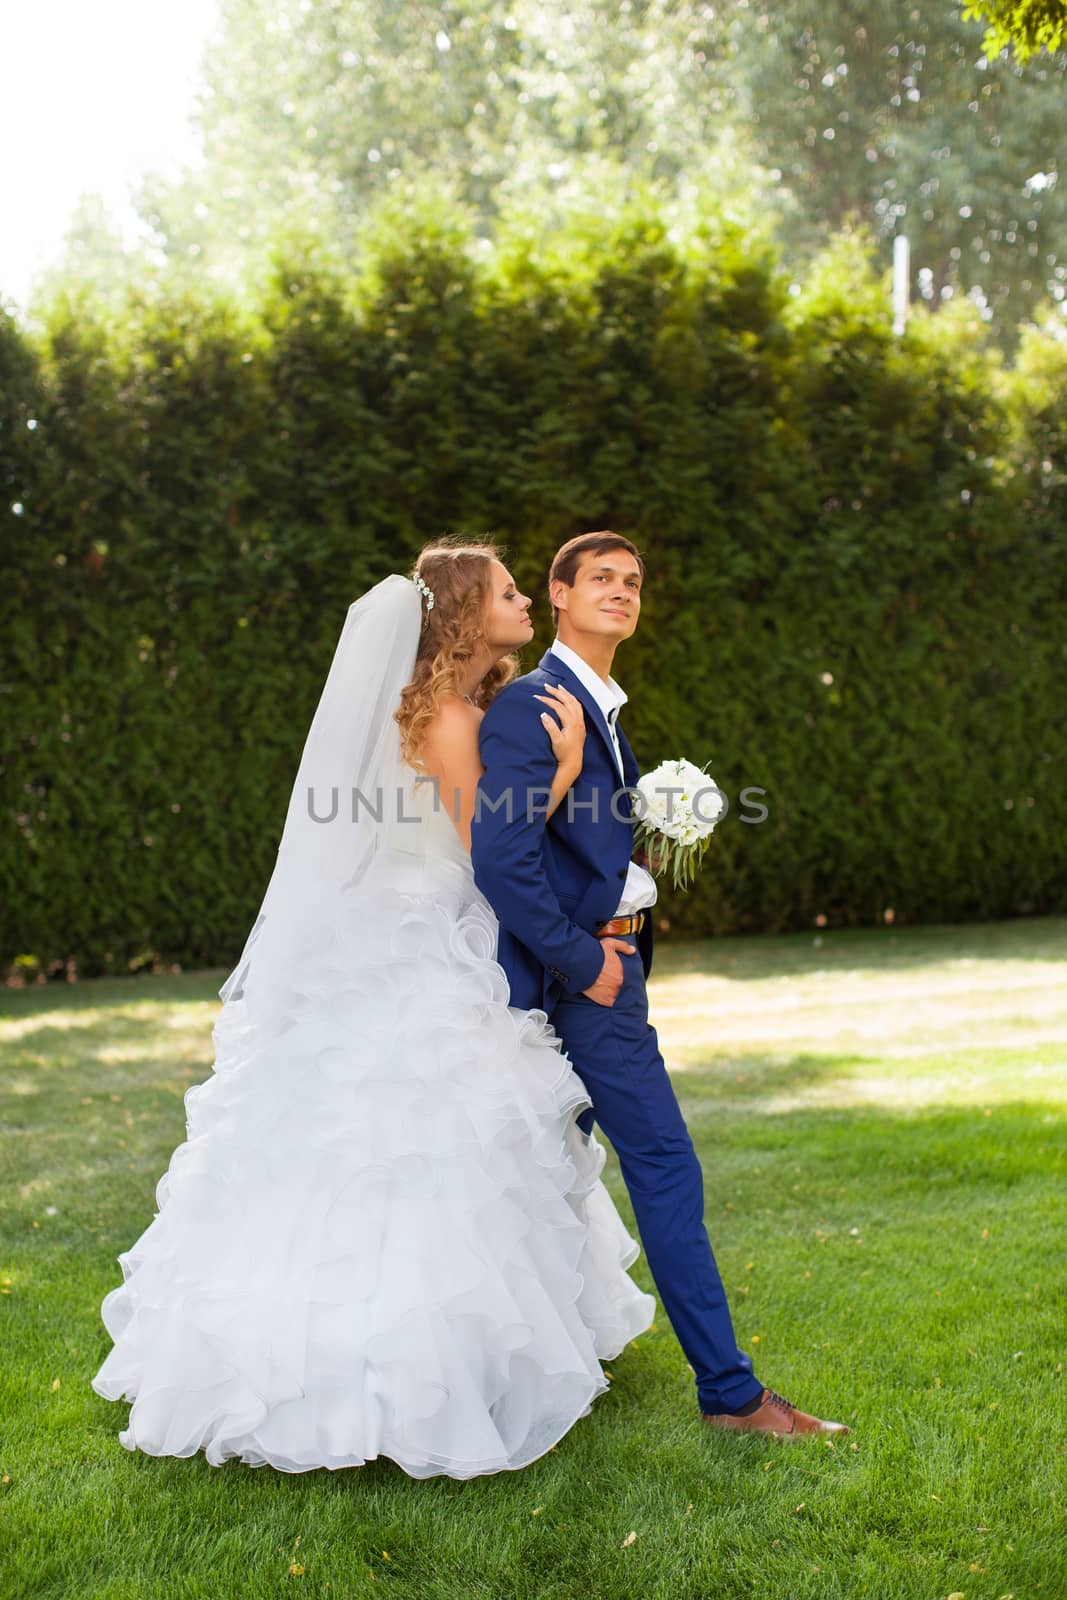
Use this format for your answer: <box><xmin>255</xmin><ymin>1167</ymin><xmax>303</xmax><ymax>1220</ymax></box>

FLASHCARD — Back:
<box><xmin>394</xmin><ymin>539</ymin><xmax>518</xmax><ymax>766</ymax></box>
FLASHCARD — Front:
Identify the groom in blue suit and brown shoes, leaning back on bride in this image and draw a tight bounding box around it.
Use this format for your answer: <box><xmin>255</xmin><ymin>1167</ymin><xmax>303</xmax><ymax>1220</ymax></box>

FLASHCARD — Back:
<box><xmin>470</xmin><ymin>531</ymin><xmax>848</xmax><ymax>1437</ymax></box>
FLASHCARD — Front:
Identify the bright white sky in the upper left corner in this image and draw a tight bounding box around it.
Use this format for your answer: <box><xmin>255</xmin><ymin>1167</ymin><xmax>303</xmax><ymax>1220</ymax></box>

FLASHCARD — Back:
<box><xmin>0</xmin><ymin>0</ymin><xmax>218</xmax><ymax>306</ymax></box>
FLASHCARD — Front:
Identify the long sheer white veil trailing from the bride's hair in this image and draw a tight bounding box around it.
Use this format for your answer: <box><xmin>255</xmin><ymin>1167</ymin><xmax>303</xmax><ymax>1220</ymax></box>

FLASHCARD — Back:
<box><xmin>219</xmin><ymin>573</ymin><xmax>422</xmax><ymax>1024</ymax></box>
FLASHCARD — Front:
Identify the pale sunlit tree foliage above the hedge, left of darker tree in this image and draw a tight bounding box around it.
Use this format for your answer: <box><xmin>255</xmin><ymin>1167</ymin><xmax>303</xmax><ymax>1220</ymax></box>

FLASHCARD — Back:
<box><xmin>129</xmin><ymin>0</ymin><xmax>755</xmax><ymax>300</ymax></box>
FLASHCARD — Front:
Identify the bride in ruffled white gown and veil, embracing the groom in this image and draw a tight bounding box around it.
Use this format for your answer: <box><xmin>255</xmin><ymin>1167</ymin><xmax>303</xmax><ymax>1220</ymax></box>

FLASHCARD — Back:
<box><xmin>91</xmin><ymin>542</ymin><xmax>656</xmax><ymax>1478</ymax></box>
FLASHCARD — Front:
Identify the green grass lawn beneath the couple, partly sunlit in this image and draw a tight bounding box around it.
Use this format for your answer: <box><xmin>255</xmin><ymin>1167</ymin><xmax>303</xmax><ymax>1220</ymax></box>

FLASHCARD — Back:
<box><xmin>0</xmin><ymin>918</ymin><xmax>1067</xmax><ymax>1600</ymax></box>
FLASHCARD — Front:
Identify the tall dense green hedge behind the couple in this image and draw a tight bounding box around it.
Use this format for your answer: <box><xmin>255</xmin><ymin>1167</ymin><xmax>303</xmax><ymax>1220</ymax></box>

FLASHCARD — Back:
<box><xmin>0</xmin><ymin>203</ymin><xmax>1067</xmax><ymax>973</ymax></box>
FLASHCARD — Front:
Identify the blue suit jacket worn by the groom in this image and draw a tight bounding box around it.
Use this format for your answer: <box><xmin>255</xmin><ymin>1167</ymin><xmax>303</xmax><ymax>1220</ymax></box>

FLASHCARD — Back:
<box><xmin>470</xmin><ymin>650</ymin><xmax>653</xmax><ymax>1014</ymax></box>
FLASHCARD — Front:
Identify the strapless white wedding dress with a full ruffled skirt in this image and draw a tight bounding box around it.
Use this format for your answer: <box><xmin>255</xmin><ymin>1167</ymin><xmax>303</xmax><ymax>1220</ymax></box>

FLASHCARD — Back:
<box><xmin>91</xmin><ymin>768</ymin><xmax>654</xmax><ymax>1478</ymax></box>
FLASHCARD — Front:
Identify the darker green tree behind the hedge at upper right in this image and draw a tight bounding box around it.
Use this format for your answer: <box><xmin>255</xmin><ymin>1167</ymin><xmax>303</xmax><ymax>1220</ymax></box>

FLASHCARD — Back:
<box><xmin>744</xmin><ymin>0</ymin><xmax>1067</xmax><ymax>346</ymax></box>
